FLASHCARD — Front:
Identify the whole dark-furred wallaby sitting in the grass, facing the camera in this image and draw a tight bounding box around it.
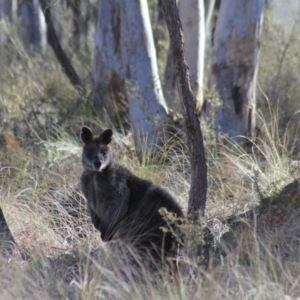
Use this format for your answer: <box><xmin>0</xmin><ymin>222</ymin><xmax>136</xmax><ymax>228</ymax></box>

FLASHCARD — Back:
<box><xmin>81</xmin><ymin>127</ymin><xmax>183</xmax><ymax>257</ymax></box>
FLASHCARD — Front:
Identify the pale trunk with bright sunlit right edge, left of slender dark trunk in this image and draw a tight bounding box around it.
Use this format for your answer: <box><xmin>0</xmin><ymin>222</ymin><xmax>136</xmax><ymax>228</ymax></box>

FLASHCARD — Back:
<box><xmin>117</xmin><ymin>0</ymin><xmax>167</xmax><ymax>155</ymax></box>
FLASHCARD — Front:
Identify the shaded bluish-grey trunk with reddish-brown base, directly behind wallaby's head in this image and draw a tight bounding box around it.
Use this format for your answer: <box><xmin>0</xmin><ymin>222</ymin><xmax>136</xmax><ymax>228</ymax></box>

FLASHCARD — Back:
<box><xmin>92</xmin><ymin>0</ymin><xmax>125</xmax><ymax>115</ymax></box>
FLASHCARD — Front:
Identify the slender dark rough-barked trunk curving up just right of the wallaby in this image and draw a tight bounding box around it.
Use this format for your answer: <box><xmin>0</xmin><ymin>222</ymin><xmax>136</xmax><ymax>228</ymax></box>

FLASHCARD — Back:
<box><xmin>163</xmin><ymin>0</ymin><xmax>207</xmax><ymax>216</ymax></box>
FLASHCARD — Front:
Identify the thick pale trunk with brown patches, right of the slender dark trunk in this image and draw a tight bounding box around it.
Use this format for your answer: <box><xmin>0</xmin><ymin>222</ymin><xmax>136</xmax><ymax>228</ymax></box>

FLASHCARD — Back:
<box><xmin>206</xmin><ymin>0</ymin><xmax>264</xmax><ymax>141</ymax></box>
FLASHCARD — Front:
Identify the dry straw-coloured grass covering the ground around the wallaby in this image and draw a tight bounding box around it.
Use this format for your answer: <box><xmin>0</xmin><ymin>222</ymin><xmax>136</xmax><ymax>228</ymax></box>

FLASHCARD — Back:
<box><xmin>0</xmin><ymin>113</ymin><xmax>300</xmax><ymax>299</ymax></box>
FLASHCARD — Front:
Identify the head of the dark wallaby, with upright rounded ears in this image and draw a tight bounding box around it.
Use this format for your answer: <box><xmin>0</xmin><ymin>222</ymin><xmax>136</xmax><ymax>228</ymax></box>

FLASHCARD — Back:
<box><xmin>80</xmin><ymin>126</ymin><xmax>113</xmax><ymax>172</ymax></box>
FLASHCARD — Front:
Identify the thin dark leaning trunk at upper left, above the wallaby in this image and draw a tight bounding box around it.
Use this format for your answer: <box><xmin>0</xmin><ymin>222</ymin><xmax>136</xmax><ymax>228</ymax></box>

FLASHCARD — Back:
<box><xmin>39</xmin><ymin>0</ymin><xmax>83</xmax><ymax>91</ymax></box>
